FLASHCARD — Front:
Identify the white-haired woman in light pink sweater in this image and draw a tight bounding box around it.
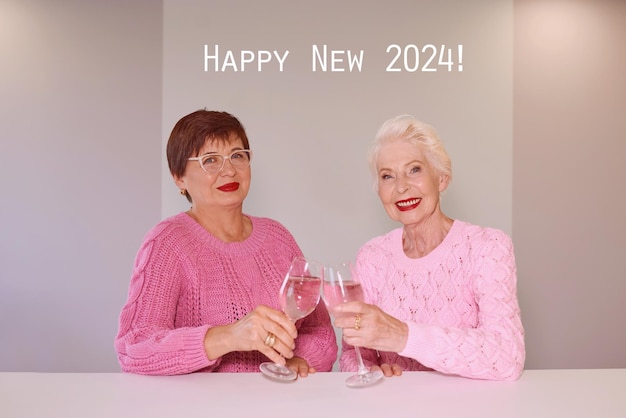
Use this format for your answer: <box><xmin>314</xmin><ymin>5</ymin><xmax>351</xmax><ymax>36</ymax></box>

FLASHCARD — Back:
<box><xmin>335</xmin><ymin>115</ymin><xmax>525</xmax><ymax>380</ymax></box>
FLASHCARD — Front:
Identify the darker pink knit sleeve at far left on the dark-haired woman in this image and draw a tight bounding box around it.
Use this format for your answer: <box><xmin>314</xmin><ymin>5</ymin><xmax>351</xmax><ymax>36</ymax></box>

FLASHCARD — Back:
<box><xmin>115</xmin><ymin>229</ymin><xmax>217</xmax><ymax>375</ymax></box>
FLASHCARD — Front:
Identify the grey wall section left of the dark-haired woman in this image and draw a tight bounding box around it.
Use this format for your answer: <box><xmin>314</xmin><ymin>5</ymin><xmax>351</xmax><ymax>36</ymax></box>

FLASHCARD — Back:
<box><xmin>0</xmin><ymin>0</ymin><xmax>162</xmax><ymax>371</ymax></box>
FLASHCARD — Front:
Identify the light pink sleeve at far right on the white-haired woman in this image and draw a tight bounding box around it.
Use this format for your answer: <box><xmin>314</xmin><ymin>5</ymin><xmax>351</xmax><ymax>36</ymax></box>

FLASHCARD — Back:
<box><xmin>398</xmin><ymin>230</ymin><xmax>525</xmax><ymax>380</ymax></box>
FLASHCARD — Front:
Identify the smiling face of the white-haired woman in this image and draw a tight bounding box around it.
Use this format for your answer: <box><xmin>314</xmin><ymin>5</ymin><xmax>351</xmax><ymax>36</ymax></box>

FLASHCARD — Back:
<box><xmin>376</xmin><ymin>139</ymin><xmax>449</xmax><ymax>225</ymax></box>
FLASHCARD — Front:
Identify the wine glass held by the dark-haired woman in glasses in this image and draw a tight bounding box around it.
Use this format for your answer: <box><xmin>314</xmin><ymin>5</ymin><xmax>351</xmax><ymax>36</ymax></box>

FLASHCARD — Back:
<box><xmin>260</xmin><ymin>257</ymin><xmax>324</xmax><ymax>380</ymax></box>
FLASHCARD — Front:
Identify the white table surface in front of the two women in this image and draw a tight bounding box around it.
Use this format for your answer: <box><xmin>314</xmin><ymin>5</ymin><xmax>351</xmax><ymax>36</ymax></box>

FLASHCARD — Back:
<box><xmin>0</xmin><ymin>369</ymin><xmax>626</xmax><ymax>418</ymax></box>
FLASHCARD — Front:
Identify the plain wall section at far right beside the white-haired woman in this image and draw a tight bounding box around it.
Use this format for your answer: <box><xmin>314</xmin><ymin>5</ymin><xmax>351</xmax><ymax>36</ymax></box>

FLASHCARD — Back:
<box><xmin>513</xmin><ymin>0</ymin><xmax>626</xmax><ymax>368</ymax></box>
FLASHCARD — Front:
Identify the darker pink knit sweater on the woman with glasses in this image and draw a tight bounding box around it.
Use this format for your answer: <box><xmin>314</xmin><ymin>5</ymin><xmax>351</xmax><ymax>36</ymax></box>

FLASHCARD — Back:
<box><xmin>115</xmin><ymin>213</ymin><xmax>337</xmax><ymax>375</ymax></box>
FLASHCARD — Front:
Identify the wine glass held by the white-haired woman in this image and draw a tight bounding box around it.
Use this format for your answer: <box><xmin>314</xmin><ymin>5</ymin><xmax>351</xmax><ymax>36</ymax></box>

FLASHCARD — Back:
<box><xmin>322</xmin><ymin>262</ymin><xmax>384</xmax><ymax>387</ymax></box>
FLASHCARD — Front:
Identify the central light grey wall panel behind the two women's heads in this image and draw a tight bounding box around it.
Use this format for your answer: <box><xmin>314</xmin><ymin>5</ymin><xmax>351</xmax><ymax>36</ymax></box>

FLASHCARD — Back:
<box><xmin>162</xmin><ymin>0</ymin><xmax>513</xmax><ymax>262</ymax></box>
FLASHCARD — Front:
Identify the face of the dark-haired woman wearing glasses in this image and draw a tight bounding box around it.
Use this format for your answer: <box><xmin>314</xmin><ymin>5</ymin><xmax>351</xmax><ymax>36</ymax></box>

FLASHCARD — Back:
<box><xmin>174</xmin><ymin>133</ymin><xmax>251</xmax><ymax>210</ymax></box>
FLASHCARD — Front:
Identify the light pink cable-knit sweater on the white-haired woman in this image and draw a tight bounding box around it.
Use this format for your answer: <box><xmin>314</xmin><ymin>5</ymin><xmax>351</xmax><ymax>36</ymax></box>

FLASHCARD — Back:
<box><xmin>340</xmin><ymin>220</ymin><xmax>525</xmax><ymax>380</ymax></box>
